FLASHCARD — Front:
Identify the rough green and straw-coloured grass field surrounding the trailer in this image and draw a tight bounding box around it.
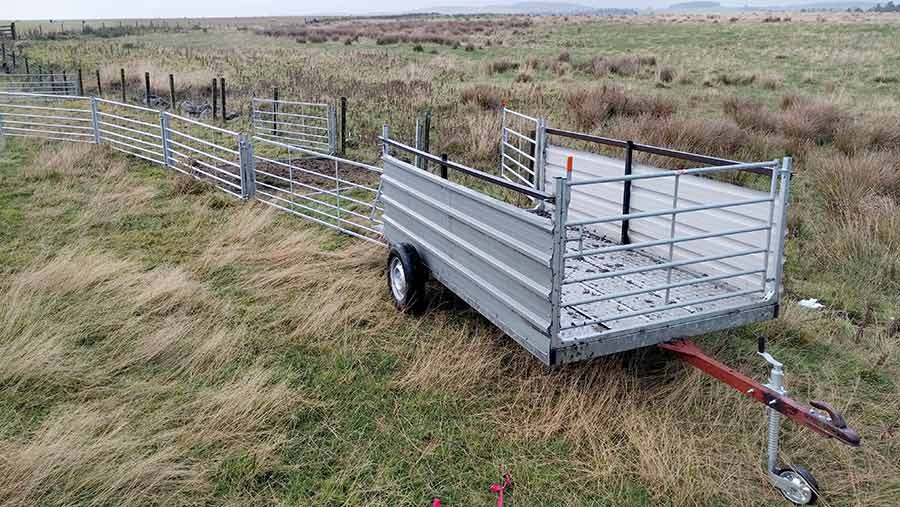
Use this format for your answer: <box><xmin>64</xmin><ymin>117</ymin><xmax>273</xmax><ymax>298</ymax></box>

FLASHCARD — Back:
<box><xmin>0</xmin><ymin>9</ymin><xmax>900</xmax><ymax>507</ymax></box>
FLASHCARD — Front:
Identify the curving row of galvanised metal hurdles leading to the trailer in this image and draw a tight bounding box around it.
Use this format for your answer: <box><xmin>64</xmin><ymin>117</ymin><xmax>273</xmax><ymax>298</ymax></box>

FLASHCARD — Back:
<box><xmin>0</xmin><ymin>91</ymin><xmax>383</xmax><ymax>243</ymax></box>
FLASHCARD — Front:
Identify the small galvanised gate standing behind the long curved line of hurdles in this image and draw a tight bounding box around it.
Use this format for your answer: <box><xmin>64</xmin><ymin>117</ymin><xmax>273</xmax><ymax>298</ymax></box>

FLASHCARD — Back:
<box><xmin>251</xmin><ymin>98</ymin><xmax>337</xmax><ymax>155</ymax></box>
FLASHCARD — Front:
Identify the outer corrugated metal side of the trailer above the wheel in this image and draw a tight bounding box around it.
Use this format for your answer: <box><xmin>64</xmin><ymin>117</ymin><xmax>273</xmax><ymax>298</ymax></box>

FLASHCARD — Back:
<box><xmin>381</xmin><ymin>156</ymin><xmax>553</xmax><ymax>363</ymax></box>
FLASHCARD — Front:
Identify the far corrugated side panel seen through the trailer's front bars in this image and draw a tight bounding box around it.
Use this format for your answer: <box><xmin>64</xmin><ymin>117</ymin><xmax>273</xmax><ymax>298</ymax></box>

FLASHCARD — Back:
<box><xmin>546</xmin><ymin>146</ymin><xmax>778</xmax><ymax>287</ymax></box>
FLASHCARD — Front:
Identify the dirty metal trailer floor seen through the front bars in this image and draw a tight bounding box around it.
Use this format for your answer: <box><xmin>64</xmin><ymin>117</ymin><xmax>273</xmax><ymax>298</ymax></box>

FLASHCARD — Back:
<box><xmin>560</xmin><ymin>231</ymin><xmax>759</xmax><ymax>341</ymax></box>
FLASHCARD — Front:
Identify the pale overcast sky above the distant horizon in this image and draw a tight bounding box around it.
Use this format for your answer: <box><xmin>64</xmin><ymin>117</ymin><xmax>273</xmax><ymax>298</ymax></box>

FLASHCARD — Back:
<box><xmin>0</xmin><ymin>0</ymin><xmax>824</xmax><ymax>19</ymax></box>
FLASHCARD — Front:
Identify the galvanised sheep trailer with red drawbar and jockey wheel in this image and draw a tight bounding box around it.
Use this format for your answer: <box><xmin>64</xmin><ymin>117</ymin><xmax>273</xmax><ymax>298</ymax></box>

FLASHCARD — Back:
<box><xmin>379</xmin><ymin>110</ymin><xmax>859</xmax><ymax>504</ymax></box>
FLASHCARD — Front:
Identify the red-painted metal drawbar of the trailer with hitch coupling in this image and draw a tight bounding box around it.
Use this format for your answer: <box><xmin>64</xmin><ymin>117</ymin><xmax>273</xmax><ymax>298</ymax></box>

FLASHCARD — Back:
<box><xmin>658</xmin><ymin>340</ymin><xmax>860</xmax><ymax>447</ymax></box>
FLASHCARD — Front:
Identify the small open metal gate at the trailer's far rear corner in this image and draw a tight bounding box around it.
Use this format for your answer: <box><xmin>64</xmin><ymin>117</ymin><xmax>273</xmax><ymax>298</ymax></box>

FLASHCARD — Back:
<box><xmin>500</xmin><ymin>107</ymin><xmax>546</xmax><ymax>190</ymax></box>
